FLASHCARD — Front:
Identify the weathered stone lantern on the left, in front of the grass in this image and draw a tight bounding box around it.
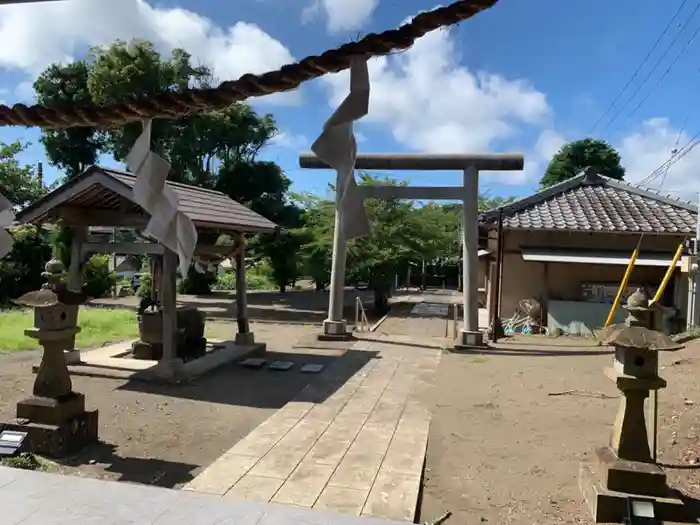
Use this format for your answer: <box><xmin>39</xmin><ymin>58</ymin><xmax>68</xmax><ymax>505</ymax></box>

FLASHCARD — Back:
<box><xmin>2</xmin><ymin>260</ymin><xmax>98</xmax><ymax>457</ymax></box>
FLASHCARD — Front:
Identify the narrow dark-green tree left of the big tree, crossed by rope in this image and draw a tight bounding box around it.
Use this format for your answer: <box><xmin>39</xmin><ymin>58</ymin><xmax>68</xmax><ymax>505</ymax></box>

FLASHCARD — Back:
<box><xmin>34</xmin><ymin>60</ymin><xmax>105</xmax><ymax>178</ymax></box>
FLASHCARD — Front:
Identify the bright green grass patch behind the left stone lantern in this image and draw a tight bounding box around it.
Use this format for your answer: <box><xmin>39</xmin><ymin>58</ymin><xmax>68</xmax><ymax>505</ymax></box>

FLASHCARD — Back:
<box><xmin>0</xmin><ymin>308</ymin><xmax>139</xmax><ymax>352</ymax></box>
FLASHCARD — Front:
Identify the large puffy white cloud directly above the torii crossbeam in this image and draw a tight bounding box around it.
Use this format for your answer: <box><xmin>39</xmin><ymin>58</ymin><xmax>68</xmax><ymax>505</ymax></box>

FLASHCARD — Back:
<box><xmin>324</xmin><ymin>25</ymin><xmax>550</xmax><ymax>160</ymax></box>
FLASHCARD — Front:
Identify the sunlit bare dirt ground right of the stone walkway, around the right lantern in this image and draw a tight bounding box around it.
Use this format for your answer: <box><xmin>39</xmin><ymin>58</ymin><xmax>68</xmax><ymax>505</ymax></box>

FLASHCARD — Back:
<box><xmin>372</xmin><ymin>294</ymin><xmax>700</xmax><ymax>525</ymax></box>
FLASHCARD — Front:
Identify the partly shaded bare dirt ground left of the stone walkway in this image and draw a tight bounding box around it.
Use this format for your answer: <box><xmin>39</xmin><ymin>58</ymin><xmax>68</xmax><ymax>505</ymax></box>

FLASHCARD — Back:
<box><xmin>0</xmin><ymin>323</ymin><xmax>358</xmax><ymax>487</ymax></box>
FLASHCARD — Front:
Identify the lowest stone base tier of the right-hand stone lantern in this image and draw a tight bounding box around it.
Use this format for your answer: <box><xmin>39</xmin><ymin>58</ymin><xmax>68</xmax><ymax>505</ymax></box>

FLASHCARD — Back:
<box><xmin>578</xmin><ymin>462</ymin><xmax>696</xmax><ymax>523</ymax></box>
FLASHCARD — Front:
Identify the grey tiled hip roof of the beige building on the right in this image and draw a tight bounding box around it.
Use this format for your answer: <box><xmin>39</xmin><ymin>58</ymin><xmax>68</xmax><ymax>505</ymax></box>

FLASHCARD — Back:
<box><xmin>481</xmin><ymin>169</ymin><xmax>697</xmax><ymax>234</ymax></box>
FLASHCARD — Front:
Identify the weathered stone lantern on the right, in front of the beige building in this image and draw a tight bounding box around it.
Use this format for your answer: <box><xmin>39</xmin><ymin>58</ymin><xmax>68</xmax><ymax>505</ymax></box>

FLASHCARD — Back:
<box><xmin>579</xmin><ymin>290</ymin><xmax>686</xmax><ymax>523</ymax></box>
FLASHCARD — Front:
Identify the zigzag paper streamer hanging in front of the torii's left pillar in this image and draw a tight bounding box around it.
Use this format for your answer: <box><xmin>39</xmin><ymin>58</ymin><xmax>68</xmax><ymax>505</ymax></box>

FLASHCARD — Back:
<box><xmin>311</xmin><ymin>57</ymin><xmax>370</xmax><ymax>239</ymax></box>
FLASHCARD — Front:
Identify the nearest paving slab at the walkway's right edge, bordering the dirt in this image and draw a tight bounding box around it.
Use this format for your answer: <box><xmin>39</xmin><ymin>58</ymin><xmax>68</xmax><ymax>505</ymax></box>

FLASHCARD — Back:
<box><xmin>362</xmin><ymin>471</ymin><xmax>421</xmax><ymax>521</ymax></box>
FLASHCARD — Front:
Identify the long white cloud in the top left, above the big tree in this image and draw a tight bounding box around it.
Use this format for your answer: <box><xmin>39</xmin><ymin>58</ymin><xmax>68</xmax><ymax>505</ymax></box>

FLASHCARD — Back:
<box><xmin>0</xmin><ymin>0</ymin><xmax>300</xmax><ymax>104</ymax></box>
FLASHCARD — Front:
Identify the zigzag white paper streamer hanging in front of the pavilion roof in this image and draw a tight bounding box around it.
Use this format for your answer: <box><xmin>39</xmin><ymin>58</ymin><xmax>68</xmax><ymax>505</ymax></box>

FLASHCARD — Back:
<box><xmin>126</xmin><ymin>120</ymin><xmax>197</xmax><ymax>277</ymax></box>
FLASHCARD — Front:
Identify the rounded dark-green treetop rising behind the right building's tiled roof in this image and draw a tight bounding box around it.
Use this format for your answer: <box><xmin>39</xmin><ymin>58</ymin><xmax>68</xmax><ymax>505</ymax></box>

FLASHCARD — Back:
<box><xmin>540</xmin><ymin>138</ymin><xmax>625</xmax><ymax>188</ymax></box>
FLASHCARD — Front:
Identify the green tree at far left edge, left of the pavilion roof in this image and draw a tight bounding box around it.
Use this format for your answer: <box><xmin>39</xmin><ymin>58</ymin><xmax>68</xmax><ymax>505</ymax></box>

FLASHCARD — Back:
<box><xmin>0</xmin><ymin>141</ymin><xmax>46</xmax><ymax>208</ymax></box>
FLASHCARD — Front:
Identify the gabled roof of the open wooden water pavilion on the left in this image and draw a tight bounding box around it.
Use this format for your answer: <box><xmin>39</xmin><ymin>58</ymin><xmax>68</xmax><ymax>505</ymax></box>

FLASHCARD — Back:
<box><xmin>16</xmin><ymin>166</ymin><xmax>279</xmax><ymax>233</ymax></box>
